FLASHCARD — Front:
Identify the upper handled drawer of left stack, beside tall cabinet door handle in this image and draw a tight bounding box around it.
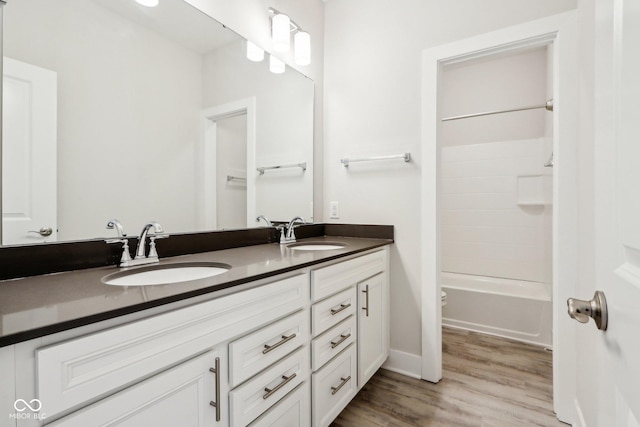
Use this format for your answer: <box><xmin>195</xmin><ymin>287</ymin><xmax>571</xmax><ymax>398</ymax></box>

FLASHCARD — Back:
<box><xmin>229</xmin><ymin>310</ymin><xmax>309</xmax><ymax>388</ymax></box>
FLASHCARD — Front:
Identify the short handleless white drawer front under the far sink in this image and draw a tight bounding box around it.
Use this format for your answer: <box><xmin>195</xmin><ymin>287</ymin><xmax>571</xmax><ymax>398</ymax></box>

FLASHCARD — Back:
<box><xmin>311</xmin><ymin>250</ymin><xmax>387</xmax><ymax>302</ymax></box>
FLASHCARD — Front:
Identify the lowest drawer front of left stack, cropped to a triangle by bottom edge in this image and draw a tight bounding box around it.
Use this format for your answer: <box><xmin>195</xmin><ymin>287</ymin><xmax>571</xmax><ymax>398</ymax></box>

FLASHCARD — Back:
<box><xmin>249</xmin><ymin>381</ymin><xmax>311</xmax><ymax>427</ymax></box>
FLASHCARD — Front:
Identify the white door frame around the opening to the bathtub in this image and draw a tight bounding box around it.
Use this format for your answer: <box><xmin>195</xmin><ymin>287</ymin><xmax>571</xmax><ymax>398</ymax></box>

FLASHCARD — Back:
<box><xmin>421</xmin><ymin>11</ymin><xmax>579</xmax><ymax>422</ymax></box>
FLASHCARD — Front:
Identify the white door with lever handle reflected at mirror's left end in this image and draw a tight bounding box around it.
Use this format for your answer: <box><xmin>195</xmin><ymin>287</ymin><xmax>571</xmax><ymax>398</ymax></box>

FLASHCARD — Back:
<box><xmin>2</xmin><ymin>57</ymin><xmax>57</xmax><ymax>245</ymax></box>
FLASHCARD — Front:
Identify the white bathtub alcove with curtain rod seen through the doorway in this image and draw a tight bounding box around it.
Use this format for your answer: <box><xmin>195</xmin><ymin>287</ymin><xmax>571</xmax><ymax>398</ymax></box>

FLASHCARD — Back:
<box><xmin>438</xmin><ymin>46</ymin><xmax>553</xmax><ymax>347</ymax></box>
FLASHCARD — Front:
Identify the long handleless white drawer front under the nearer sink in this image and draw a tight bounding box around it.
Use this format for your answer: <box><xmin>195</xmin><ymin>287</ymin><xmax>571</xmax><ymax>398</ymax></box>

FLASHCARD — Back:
<box><xmin>36</xmin><ymin>274</ymin><xmax>309</xmax><ymax>416</ymax></box>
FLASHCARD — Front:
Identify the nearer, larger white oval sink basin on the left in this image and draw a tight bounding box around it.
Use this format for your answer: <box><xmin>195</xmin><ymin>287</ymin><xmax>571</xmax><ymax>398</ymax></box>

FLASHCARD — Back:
<box><xmin>102</xmin><ymin>262</ymin><xmax>231</xmax><ymax>286</ymax></box>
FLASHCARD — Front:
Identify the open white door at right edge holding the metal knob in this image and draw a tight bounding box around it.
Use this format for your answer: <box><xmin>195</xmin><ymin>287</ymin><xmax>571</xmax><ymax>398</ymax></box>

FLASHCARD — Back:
<box><xmin>576</xmin><ymin>0</ymin><xmax>640</xmax><ymax>427</ymax></box>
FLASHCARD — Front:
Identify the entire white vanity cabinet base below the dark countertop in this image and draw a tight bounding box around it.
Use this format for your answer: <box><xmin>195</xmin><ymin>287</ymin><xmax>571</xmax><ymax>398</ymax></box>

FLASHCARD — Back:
<box><xmin>0</xmin><ymin>244</ymin><xmax>389</xmax><ymax>427</ymax></box>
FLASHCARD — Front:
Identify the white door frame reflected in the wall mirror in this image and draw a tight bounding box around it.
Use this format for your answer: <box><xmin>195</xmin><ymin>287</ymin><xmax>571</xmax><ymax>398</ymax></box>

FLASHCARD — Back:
<box><xmin>198</xmin><ymin>97</ymin><xmax>256</xmax><ymax>230</ymax></box>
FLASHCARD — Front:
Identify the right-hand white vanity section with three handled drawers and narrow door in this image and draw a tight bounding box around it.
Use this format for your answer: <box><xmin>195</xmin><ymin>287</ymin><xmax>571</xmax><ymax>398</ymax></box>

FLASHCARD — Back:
<box><xmin>311</xmin><ymin>249</ymin><xmax>389</xmax><ymax>427</ymax></box>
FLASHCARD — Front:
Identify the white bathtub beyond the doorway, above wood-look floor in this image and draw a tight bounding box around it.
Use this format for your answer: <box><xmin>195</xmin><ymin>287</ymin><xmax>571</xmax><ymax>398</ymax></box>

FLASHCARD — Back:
<box><xmin>440</xmin><ymin>272</ymin><xmax>552</xmax><ymax>348</ymax></box>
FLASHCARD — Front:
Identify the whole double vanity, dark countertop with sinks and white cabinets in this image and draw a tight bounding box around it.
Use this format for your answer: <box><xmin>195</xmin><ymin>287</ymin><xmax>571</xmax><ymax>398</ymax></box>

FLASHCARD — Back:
<box><xmin>0</xmin><ymin>225</ymin><xmax>393</xmax><ymax>426</ymax></box>
